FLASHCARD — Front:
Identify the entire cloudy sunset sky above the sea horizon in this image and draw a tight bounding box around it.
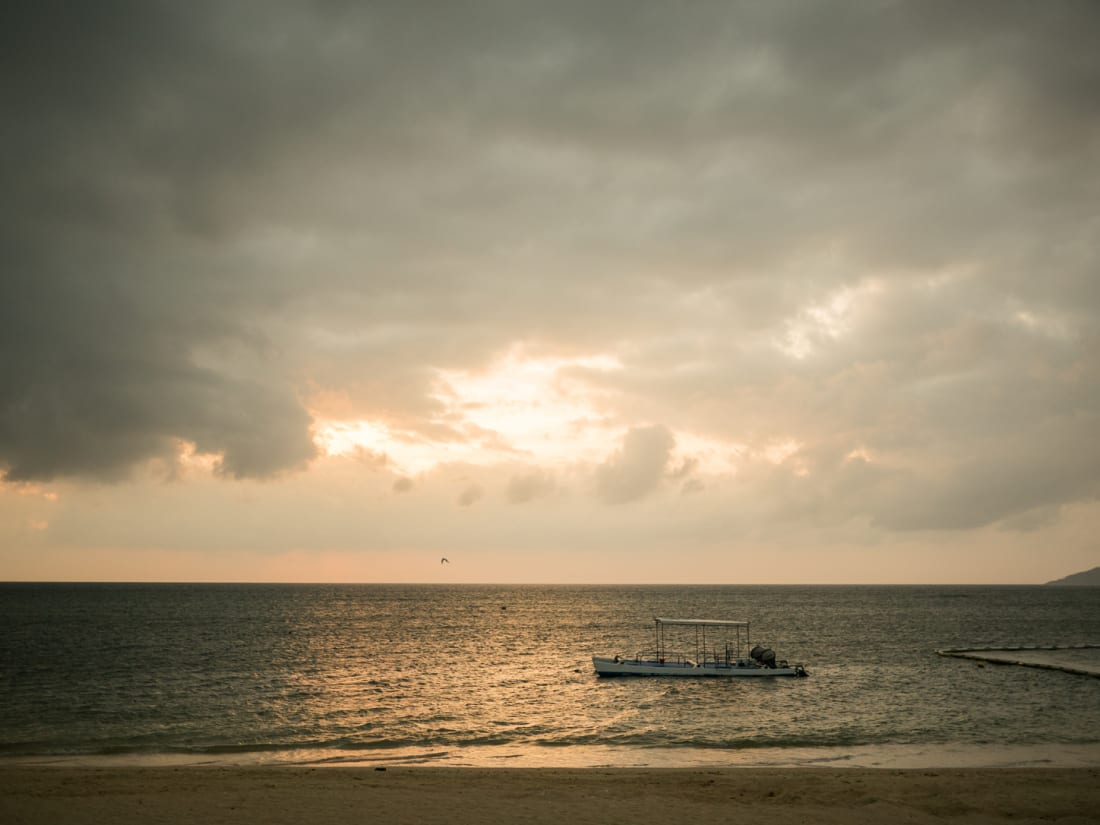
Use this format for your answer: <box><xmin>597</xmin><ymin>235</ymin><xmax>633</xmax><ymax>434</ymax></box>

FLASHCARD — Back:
<box><xmin>0</xmin><ymin>0</ymin><xmax>1100</xmax><ymax>584</ymax></box>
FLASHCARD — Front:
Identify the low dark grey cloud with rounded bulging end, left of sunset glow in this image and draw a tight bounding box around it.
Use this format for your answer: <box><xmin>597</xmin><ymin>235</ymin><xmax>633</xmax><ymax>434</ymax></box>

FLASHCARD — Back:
<box><xmin>0</xmin><ymin>275</ymin><xmax>316</xmax><ymax>481</ymax></box>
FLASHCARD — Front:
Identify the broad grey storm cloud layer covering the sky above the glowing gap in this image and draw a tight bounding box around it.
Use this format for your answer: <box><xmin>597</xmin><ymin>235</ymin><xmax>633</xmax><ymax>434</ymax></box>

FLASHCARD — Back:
<box><xmin>0</xmin><ymin>2</ymin><xmax>1100</xmax><ymax>526</ymax></box>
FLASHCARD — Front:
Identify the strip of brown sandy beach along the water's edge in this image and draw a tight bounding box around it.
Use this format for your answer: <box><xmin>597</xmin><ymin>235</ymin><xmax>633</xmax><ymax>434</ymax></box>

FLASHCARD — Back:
<box><xmin>0</xmin><ymin>765</ymin><xmax>1100</xmax><ymax>825</ymax></box>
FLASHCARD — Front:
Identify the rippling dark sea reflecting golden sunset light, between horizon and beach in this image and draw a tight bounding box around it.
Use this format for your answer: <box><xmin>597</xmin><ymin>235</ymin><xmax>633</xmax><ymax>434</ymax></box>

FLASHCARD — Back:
<box><xmin>0</xmin><ymin>583</ymin><xmax>1100</xmax><ymax>768</ymax></box>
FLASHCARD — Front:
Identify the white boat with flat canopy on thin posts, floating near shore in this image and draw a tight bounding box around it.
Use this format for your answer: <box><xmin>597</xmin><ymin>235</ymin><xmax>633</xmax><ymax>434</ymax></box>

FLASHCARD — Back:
<box><xmin>592</xmin><ymin>618</ymin><xmax>809</xmax><ymax>677</ymax></box>
